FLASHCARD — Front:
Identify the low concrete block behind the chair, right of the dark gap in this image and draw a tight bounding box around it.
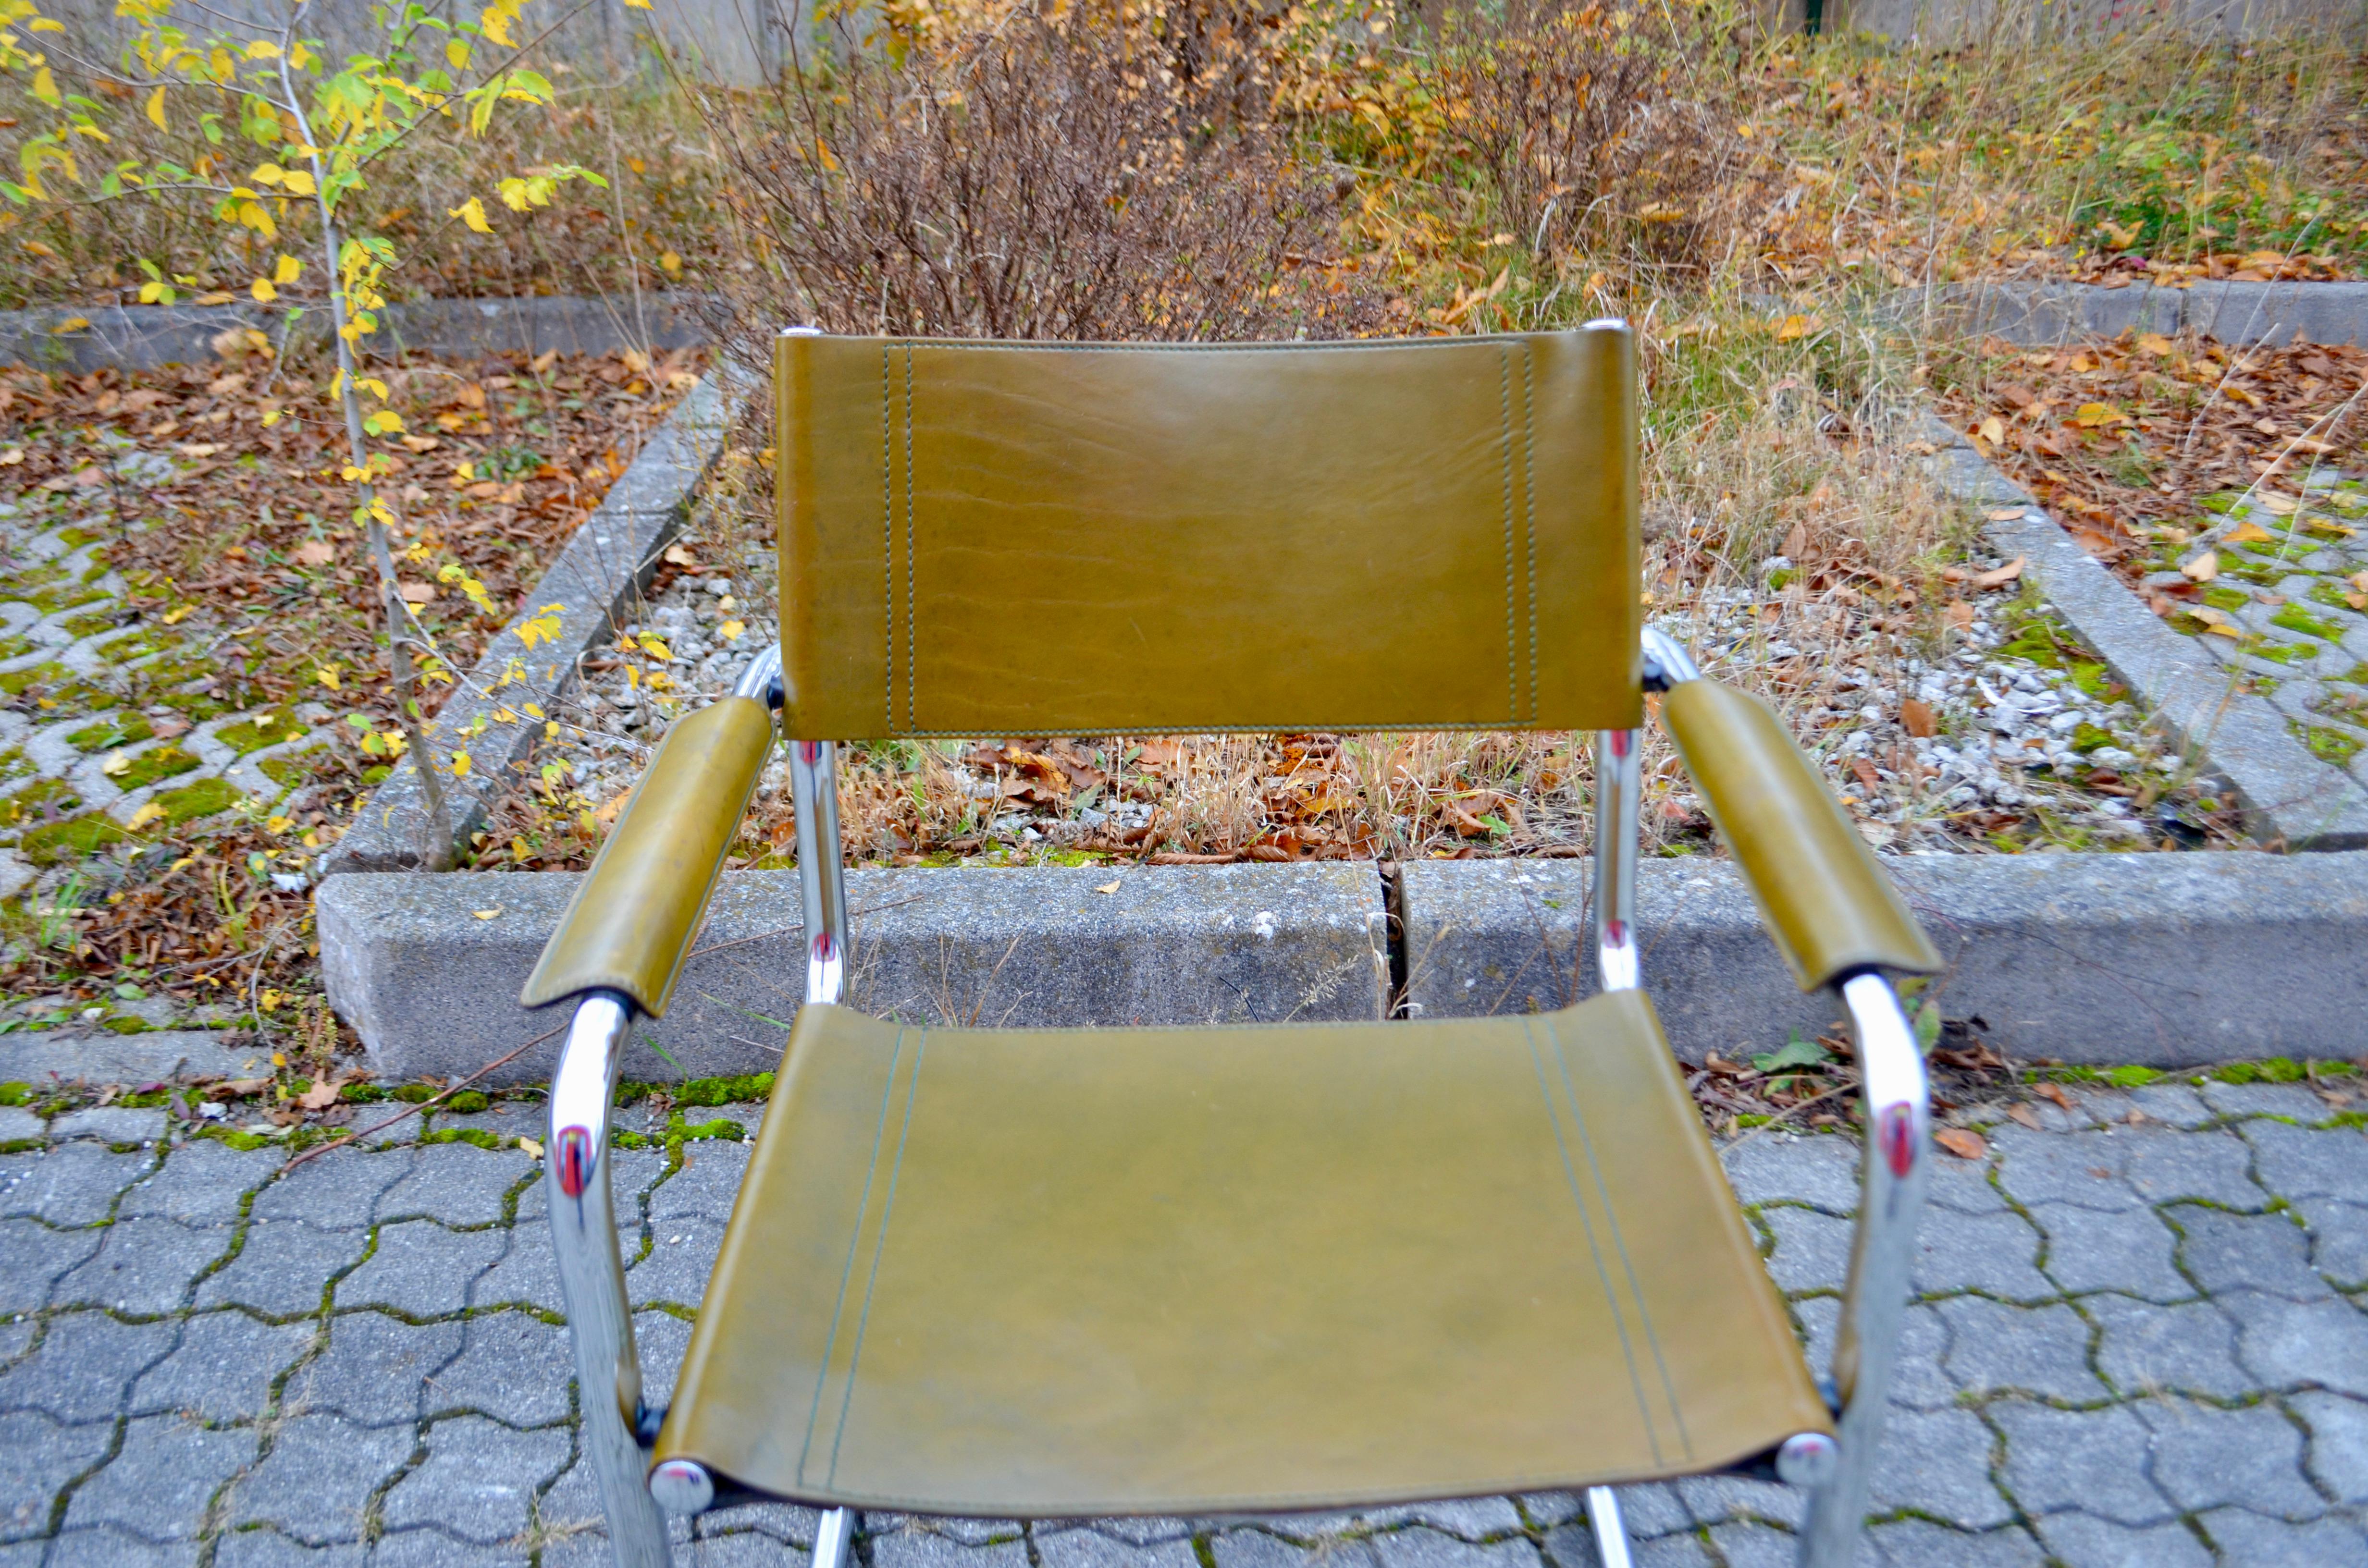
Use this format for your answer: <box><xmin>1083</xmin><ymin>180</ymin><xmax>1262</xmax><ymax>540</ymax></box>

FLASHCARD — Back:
<box><xmin>1392</xmin><ymin>853</ymin><xmax>2368</xmax><ymax>1066</ymax></box>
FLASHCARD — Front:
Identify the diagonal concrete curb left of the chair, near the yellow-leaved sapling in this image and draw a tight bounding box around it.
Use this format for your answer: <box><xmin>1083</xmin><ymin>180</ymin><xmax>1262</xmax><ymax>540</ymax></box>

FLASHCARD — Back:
<box><xmin>322</xmin><ymin>374</ymin><xmax>729</xmax><ymax>876</ymax></box>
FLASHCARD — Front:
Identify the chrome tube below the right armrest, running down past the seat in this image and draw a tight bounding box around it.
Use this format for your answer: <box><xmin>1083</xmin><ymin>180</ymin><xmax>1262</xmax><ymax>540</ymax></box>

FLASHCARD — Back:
<box><xmin>1800</xmin><ymin>973</ymin><xmax>1932</xmax><ymax>1568</ymax></box>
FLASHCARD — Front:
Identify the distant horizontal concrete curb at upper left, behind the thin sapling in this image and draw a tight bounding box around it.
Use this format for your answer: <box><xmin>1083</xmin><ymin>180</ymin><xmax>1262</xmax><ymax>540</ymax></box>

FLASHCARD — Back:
<box><xmin>0</xmin><ymin>294</ymin><xmax>706</xmax><ymax>374</ymax></box>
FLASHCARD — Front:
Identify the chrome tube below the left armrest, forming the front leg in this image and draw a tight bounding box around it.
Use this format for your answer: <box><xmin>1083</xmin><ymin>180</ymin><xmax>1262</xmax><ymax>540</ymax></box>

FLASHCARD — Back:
<box><xmin>543</xmin><ymin>990</ymin><xmax>670</xmax><ymax>1568</ymax></box>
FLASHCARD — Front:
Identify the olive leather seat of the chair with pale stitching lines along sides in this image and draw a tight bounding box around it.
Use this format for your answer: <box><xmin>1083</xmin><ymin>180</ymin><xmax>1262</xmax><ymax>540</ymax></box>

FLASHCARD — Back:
<box><xmin>656</xmin><ymin>992</ymin><xmax>1833</xmax><ymax>1516</ymax></box>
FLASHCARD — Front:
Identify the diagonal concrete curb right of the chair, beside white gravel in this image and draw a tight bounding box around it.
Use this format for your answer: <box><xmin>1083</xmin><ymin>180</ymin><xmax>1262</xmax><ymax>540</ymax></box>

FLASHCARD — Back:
<box><xmin>1923</xmin><ymin>405</ymin><xmax>2368</xmax><ymax>850</ymax></box>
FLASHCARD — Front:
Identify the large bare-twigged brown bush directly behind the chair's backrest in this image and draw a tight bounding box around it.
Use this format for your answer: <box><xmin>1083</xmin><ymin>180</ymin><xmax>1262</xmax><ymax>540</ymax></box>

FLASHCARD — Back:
<box><xmin>696</xmin><ymin>5</ymin><xmax>1378</xmax><ymax>348</ymax></box>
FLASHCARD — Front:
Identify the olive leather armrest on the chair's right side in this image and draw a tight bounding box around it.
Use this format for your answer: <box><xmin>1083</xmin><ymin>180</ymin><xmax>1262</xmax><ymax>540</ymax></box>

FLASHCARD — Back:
<box><xmin>1660</xmin><ymin>680</ymin><xmax>1942</xmax><ymax>990</ymax></box>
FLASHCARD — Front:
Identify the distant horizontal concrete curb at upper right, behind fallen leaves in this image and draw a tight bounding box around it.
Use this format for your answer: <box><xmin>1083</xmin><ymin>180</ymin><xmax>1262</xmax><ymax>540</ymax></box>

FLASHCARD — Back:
<box><xmin>1883</xmin><ymin>282</ymin><xmax>2368</xmax><ymax>348</ymax></box>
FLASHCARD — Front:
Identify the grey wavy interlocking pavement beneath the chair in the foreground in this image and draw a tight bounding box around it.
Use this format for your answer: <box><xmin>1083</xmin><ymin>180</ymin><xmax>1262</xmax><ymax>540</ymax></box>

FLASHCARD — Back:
<box><xmin>0</xmin><ymin>1082</ymin><xmax>2368</xmax><ymax>1568</ymax></box>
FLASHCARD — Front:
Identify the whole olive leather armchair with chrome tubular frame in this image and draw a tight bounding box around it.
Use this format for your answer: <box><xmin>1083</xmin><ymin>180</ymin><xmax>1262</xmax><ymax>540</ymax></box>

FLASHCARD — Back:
<box><xmin>526</xmin><ymin>322</ymin><xmax>1937</xmax><ymax>1568</ymax></box>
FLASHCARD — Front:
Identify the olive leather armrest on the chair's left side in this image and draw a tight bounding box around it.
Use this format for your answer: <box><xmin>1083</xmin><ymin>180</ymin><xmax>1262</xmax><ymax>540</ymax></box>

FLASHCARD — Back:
<box><xmin>518</xmin><ymin>697</ymin><xmax>774</xmax><ymax>1018</ymax></box>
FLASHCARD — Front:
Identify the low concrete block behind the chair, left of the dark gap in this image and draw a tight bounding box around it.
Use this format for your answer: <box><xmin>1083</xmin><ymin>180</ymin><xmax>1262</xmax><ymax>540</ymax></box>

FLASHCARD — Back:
<box><xmin>315</xmin><ymin>862</ymin><xmax>1388</xmax><ymax>1082</ymax></box>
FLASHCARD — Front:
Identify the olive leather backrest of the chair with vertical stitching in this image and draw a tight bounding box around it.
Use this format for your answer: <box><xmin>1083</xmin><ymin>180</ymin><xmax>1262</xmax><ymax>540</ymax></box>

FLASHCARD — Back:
<box><xmin>774</xmin><ymin>322</ymin><xmax>1643</xmax><ymax>739</ymax></box>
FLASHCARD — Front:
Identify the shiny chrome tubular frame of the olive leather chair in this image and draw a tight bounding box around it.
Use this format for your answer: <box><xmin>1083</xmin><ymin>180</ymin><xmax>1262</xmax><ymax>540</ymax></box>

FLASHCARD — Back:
<box><xmin>544</xmin><ymin>329</ymin><xmax>1930</xmax><ymax>1568</ymax></box>
